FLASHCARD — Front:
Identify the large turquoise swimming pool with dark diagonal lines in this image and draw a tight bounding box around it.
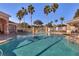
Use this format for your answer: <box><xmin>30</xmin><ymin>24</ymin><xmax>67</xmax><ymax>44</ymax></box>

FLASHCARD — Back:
<box><xmin>0</xmin><ymin>35</ymin><xmax>79</xmax><ymax>56</ymax></box>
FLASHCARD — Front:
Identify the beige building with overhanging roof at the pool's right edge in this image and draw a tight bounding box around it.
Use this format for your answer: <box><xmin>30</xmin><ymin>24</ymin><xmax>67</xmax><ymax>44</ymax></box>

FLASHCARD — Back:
<box><xmin>67</xmin><ymin>17</ymin><xmax>79</xmax><ymax>34</ymax></box>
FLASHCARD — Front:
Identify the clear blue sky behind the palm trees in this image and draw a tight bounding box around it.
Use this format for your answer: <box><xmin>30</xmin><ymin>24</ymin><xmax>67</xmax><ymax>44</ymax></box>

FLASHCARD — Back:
<box><xmin>0</xmin><ymin>3</ymin><xmax>79</xmax><ymax>24</ymax></box>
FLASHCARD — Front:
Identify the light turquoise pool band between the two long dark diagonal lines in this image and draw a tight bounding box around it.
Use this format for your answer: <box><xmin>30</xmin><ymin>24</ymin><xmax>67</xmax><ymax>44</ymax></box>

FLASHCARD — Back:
<box><xmin>13</xmin><ymin>37</ymin><xmax>62</xmax><ymax>56</ymax></box>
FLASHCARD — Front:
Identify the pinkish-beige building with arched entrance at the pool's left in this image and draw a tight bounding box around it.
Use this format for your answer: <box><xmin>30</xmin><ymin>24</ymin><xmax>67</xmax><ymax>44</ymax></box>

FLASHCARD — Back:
<box><xmin>0</xmin><ymin>11</ymin><xmax>16</xmax><ymax>34</ymax></box>
